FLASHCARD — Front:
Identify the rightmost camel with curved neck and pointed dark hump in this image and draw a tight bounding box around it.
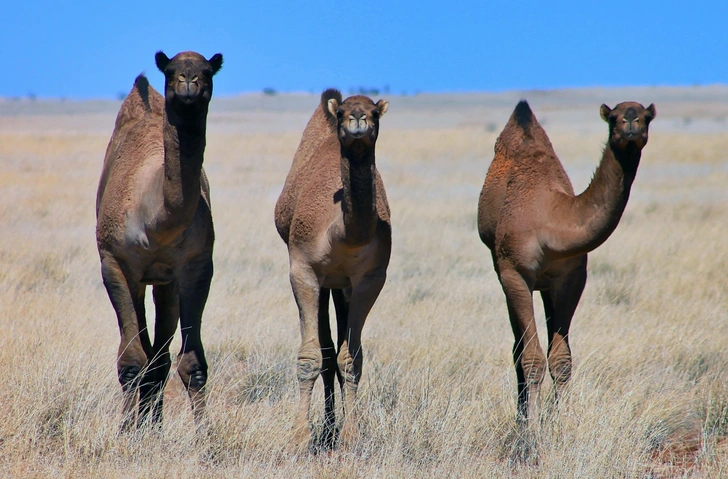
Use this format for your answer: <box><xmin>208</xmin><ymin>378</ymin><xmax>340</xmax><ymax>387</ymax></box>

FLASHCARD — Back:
<box><xmin>478</xmin><ymin>101</ymin><xmax>656</xmax><ymax>420</ymax></box>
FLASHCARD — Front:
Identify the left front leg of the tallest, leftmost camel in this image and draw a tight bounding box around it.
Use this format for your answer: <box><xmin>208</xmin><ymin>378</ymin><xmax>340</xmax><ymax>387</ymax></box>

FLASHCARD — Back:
<box><xmin>101</xmin><ymin>255</ymin><xmax>151</xmax><ymax>431</ymax></box>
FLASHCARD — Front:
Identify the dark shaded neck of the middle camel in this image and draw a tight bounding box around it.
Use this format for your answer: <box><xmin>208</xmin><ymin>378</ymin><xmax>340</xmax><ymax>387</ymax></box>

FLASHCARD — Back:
<box><xmin>341</xmin><ymin>147</ymin><xmax>377</xmax><ymax>246</ymax></box>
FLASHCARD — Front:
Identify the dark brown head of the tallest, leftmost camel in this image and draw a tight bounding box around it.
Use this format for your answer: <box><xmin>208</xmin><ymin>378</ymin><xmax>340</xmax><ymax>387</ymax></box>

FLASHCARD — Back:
<box><xmin>154</xmin><ymin>51</ymin><xmax>222</xmax><ymax>108</ymax></box>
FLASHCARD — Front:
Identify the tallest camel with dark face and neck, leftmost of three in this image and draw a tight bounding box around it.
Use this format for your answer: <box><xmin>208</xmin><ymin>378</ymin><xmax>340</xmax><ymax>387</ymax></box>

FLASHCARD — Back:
<box><xmin>96</xmin><ymin>51</ymin><xmax>222</xmax><ymax>430</ymax></box>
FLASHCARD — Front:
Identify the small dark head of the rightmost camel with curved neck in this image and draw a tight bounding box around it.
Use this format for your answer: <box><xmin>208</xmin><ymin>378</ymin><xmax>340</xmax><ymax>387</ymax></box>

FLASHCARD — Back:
<box><xmin>599</xmin><ymin>101</ymin><xmax>657</xmax><ymax>151</ymax></box>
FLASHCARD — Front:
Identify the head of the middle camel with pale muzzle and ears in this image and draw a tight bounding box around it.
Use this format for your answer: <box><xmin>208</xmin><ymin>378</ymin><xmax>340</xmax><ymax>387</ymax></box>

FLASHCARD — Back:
<box><xmin>322</xmin><ymin>92</ymin><xmax>389</xmax><ymax>149</ymax></box>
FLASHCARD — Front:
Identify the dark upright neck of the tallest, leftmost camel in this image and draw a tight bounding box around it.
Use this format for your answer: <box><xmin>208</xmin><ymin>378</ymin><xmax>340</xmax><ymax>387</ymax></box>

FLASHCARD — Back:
<box><xmin>163</xmin><ymin>106</ymin><xmax>207</xmax><ymax>228</ymax></box>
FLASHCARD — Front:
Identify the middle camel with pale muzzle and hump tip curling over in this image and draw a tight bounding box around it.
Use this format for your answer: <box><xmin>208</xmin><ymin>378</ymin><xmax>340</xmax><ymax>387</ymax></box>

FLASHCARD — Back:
<box><xmin>275</xmin><ymin>89</ymin><xmax>392</xmax><ymax>449</ymax></box>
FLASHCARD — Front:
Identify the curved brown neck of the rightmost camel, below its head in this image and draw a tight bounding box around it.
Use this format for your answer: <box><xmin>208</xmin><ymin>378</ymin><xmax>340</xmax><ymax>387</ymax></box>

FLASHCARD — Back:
<box><xmin>566</xmin><ymin>142</ymin><xmax>641</xmax><ymax>256</ymax></box>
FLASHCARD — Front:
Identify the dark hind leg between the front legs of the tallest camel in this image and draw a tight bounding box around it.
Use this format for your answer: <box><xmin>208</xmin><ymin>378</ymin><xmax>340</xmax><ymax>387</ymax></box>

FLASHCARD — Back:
<box><xmin>139</xmin><ymin>282</ymin><xmax>179</xmax><ymax>425</ymax></box>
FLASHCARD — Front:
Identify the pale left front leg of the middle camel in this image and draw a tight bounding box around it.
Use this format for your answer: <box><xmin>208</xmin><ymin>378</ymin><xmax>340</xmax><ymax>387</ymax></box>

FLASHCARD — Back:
<box><xmin>290</xmin><ymin>259</ymin><xmax>328</xmax><ymax>452</ymax></box>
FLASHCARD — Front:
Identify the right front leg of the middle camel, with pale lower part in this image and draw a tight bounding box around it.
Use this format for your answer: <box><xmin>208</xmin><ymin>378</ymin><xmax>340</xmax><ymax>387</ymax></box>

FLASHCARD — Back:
<box><xmin>337</xmin><ymin>274</ymin><xmax>386</xmax><ymax>449</ymax></box>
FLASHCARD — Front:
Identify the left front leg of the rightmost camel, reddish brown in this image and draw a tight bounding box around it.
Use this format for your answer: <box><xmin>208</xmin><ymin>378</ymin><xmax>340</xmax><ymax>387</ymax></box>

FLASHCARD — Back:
<box><xmin>499</xmin><ymin>265</ymin><xmax>546</xmax><ymax>420</ymax></box>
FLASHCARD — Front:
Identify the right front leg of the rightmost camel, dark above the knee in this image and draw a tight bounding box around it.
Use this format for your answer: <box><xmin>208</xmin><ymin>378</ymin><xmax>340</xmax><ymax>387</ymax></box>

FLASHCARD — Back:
<box><xmin>541</xmin><ymin>255</ymin><xmax>587</xmax><ymax>401</ymax></box>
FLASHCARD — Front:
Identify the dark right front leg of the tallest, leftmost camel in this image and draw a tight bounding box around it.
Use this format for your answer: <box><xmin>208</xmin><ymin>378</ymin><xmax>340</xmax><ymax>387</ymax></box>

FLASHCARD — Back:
<box><xmin>178</xmin><ymin>252</ymin><xmax>213</xmax><ymax>424</ymax></box>
